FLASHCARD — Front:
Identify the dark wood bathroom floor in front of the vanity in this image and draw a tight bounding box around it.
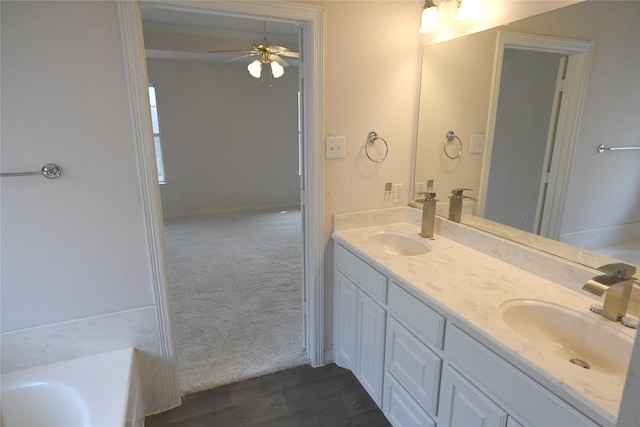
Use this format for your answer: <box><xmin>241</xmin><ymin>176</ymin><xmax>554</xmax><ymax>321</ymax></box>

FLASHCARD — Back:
<box><xmin>146</xmin><ymin>364</ymin><xmax>390</xmax><ymax>427</ymax></box>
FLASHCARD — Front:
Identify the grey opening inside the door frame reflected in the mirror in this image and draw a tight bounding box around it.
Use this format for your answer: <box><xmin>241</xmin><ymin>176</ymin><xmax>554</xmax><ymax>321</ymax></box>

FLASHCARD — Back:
<box><xmin>484</xmin><ymin>48</ymin><xmax>567</xmax><ymax>235</ymax></box>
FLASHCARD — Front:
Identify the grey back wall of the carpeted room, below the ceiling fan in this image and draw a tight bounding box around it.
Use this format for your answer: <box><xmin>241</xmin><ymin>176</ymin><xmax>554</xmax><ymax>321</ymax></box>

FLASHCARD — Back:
<box><xmin>147</xmin><ymin>59</ymin><xmax>300</xmax><ymax>216</ymax></box>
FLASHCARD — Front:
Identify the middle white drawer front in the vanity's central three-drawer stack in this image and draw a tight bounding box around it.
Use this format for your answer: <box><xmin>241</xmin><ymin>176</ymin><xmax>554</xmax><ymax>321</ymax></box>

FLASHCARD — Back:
<box><xmin>386</xmin><ymin>316</ymin><xmax>442</xmax><ymax>415</ymax></box>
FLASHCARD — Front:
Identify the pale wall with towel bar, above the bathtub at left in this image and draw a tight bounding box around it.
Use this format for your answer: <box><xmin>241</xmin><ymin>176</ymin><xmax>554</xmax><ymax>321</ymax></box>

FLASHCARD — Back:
<box><xmin>0</xmin><ymin>1</ymin><xmax>172</xmax><ymax>411</ymax></box>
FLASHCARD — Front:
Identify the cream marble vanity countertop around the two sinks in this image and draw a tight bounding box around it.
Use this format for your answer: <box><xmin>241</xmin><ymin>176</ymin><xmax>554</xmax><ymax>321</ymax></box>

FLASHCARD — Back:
<box><xmin>333</xmin><ymin>211</ymin><xmax>635</xmax><ymax>425</ymax></box>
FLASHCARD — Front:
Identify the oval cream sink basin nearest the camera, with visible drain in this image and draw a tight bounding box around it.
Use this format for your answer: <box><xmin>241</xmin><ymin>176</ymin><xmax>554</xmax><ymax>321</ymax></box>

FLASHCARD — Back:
<box><xmin>499</xmin><ymin>299</ymin><xmax>633</xmax><ymax>377</ymax></box>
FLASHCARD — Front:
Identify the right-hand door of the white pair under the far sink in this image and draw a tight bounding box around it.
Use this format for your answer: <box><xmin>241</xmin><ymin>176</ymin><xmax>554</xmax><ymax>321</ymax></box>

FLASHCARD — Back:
<box><xmin>355</xmin><ymin>290</ymin><xmax>386</xmax><ymax>407</ymax></box>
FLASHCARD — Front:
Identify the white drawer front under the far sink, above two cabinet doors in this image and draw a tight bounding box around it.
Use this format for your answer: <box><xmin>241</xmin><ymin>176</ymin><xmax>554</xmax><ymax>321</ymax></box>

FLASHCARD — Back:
<box><xmin>335</xmin><ymin>245</ymin><xmax>387</xmax><ymax>304</ymax></box>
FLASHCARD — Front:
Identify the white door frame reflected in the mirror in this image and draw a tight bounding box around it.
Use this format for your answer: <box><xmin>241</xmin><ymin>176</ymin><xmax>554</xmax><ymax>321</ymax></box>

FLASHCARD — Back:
<box><xmin>478</xmin><ymin>31</ymin><xmax>593</xmax><ymax>239</ymax></box>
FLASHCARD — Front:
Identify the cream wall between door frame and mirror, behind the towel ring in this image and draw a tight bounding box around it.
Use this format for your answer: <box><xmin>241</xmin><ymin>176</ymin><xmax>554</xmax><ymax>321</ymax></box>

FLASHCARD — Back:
<box><xmin>312</xmin><ymin>1</ymin><xmax>422</xmax><ymax>351</ymax></box>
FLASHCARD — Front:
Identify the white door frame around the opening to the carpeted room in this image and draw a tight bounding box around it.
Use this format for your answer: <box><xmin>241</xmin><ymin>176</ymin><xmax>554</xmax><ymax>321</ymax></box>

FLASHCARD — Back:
<box><xmin>117</xmin><ymin>0</ymin><xmax>324</xmax><ymax>406</ymax></box>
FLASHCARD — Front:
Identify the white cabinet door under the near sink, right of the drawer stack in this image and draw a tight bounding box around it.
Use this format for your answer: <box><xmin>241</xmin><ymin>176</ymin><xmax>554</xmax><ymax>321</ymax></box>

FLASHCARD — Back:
<box><xmin>438</xmin><ymin>365</ymin><xmax>509</xmax><ymax>427</ymax></box>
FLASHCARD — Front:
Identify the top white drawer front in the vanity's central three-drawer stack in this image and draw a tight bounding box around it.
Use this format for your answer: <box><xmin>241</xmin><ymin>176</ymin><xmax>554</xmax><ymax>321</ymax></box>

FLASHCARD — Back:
<box><xmin>388</xmin><ymin>282</ymin><xmax>445</xmax><ymax>349</ymax></box>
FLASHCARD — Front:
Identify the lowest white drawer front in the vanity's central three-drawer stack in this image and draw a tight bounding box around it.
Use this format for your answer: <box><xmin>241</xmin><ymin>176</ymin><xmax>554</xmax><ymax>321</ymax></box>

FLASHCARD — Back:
<box><xmin>382</xmin><ymin>372</ymin><xmax>436</xmax><ymax>427</ymax></box>
